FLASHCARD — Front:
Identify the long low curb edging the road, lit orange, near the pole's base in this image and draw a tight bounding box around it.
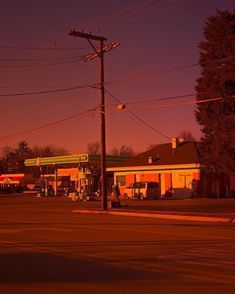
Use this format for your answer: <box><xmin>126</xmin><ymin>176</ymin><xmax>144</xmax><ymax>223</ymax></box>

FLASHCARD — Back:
<box><xmin>72</xmin><ymin>209</ymin><xmax>235</xmax><ymax>223</ymax></box>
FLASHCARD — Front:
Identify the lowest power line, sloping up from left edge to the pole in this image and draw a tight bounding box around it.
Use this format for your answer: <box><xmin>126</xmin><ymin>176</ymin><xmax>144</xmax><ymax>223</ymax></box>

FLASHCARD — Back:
<box><xmin>0</xmin><ymin>107</ymin><xmax>98</xmax><ymax>140</ymax></box>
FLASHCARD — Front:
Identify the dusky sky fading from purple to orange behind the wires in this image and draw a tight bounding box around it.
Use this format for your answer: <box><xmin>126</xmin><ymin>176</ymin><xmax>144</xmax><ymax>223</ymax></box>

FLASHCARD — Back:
<box><xmin>0</xmin><ymin>0</ymin><xmax>234</xmax><ymax>153</ymax></box>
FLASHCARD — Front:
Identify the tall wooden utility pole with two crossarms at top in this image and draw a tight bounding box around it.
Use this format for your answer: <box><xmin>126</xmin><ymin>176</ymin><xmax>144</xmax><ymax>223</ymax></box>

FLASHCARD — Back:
<box><xmin>69</xmin><ymin>30</ymin><xmax>119</xmax><ymax>210</ymax></box>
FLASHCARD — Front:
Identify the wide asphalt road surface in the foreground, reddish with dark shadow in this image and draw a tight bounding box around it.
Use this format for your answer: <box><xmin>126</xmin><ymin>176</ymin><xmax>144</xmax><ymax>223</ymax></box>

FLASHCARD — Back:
<box><xmin>0</xmin><ymin>195</ymin><xmax>235</xmax><ymax>294</ymax></box>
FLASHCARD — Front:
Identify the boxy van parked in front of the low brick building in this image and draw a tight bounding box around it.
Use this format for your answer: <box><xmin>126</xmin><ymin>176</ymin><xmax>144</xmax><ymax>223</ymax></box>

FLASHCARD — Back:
<box><xmin>124</xmin><ymin>182</ymin><xmax>161</xmax><ymax>200</ymax></box>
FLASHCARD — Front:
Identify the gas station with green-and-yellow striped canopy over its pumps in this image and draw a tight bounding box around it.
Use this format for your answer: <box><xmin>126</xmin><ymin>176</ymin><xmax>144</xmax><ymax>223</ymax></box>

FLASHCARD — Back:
<box><xmin>24</xmin><ymin>154</ymin><xmax>127</xmax><ymax>196</ymax></box>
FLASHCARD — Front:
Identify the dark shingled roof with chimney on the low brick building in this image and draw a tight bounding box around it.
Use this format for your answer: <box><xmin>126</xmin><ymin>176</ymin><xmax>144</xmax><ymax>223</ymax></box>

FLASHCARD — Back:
<box><xmin>109</xmin><ymin>142</ymin><xmax>200</xmax><ymax>167</ymax></box>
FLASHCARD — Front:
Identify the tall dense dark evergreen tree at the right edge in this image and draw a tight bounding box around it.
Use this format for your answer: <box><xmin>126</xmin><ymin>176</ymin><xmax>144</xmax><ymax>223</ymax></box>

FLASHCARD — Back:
<box><xmin>196</xmin><ymin>11</ymin><xmax>235</xmax><ymax>173</ymax></box>
